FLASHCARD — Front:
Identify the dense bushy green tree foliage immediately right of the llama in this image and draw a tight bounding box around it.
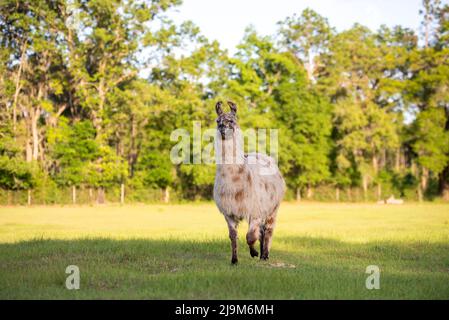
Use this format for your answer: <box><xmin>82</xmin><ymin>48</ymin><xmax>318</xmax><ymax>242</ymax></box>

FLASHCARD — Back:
<box><xmin>273</xmin><ymin>54</ymin><xmax>332</xmax><ymax>187</ymax></box>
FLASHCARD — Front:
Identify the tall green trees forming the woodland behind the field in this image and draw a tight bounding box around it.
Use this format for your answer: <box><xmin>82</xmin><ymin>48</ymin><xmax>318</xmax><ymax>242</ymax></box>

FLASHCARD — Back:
<box><xmin>0</xmin><ymin>0</ymin><xmax>449</xmax><ymax>204</ymax></box>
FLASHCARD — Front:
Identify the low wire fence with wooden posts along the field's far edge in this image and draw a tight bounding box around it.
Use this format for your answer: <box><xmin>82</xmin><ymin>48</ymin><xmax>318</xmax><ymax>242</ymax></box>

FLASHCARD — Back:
<box><xmin>0</xmin><ymin>185</ymin><xmax>424</xmax><ymax>206</ymax></box>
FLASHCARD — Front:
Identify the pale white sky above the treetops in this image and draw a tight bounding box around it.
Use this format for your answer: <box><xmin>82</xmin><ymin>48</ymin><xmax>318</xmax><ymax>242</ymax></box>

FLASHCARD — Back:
<box><xmin>169</xmin><ymin>0</ymin><xmax>430</xmax><ymax>53</ymax></box>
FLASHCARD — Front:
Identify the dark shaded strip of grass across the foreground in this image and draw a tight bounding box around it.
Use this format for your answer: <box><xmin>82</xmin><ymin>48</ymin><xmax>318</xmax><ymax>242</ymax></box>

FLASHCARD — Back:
<box><xmin>0</xmin><ymin>236</ymin><xmax>449</xmax><ymax>299</ymax></box>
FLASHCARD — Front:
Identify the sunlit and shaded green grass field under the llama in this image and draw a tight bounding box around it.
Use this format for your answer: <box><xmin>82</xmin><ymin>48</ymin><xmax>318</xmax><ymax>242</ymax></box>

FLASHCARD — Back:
<box><xmin>0</xmin><ymin>203</ymin><xmax>449</xmax><ymax>299</ymax></box>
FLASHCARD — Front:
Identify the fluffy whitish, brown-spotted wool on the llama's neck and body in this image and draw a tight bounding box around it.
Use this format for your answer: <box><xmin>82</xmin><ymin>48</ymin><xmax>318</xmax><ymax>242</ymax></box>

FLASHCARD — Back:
<box><xmin>214</xmin><ymin>129</ymin><xmax>285</xmax><ymax>223</ymax></box>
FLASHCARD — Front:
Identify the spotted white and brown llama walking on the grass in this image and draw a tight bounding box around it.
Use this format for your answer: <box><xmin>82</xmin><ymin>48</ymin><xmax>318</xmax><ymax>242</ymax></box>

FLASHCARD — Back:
<box><xmin>214</xmin><ymin>101</ymin><xmax>285</xmax><ymax>264</ymax></box>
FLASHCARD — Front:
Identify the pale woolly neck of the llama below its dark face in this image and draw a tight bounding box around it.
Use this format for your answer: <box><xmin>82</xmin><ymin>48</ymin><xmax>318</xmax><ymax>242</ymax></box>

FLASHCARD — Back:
<box><xmin>215</xmin><ymin>129</ymin><xmax>244</xmax><ymax>168</ymax></box>
